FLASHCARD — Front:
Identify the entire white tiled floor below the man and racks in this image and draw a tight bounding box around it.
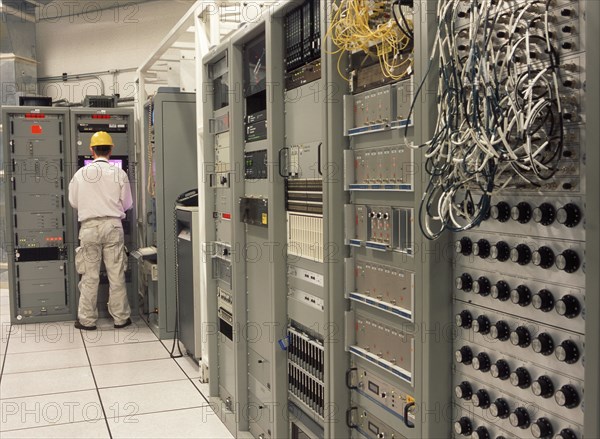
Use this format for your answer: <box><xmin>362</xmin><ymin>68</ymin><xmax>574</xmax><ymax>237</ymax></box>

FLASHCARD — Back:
<box><xmin>0</xmin><ymin>290</ymin><xmax>232</xmax><ymax>439</ymax></box>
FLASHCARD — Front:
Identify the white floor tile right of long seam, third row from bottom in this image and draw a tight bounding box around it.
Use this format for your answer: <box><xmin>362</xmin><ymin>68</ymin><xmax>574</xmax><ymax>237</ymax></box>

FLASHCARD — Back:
<box><xmin>93</xmin><ymin>358</ymin><xmax>186</xmax><ymax>387</ymax></box>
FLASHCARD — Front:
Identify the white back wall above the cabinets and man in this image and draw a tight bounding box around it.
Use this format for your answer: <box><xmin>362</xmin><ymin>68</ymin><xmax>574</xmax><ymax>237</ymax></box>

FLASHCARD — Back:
<box><xmin>36</xmin><ymin>0</ymin><xmax>194</xmax><ymax>102</ymax></box>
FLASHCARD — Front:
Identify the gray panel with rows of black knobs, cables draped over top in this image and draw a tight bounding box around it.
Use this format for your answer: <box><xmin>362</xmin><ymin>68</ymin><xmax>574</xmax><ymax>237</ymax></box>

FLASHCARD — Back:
<box><xmin>420</xmin><ymin>1</ymin><xmax>590</xmax><ymax>438</ymax></box>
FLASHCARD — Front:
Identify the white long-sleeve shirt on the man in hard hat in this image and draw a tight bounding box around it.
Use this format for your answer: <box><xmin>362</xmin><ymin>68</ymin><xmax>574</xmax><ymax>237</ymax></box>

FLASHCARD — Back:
<box><xmin>69</xmin><ymin>158</ymin><xmax>133</xmax><ymax>221</ymax></box>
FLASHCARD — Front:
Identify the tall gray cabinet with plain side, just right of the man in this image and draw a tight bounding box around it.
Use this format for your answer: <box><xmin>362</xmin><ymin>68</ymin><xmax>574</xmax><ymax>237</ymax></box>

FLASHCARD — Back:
<box><xmin>141</xmin><ymin>89</ymin><xmax>198</xmax><ymax>339</ymax></box>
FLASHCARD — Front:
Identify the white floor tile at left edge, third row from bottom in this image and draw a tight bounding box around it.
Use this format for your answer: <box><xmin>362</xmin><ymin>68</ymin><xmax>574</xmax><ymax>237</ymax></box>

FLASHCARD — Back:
<box><xmin>0</xmin><ymin>366</ymin><xmax>95</xmax><ymax>399</ymax></box>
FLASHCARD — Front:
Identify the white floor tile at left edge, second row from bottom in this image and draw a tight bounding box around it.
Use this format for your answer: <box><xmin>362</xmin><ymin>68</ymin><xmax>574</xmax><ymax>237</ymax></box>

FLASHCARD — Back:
<box><xmin>0</xmin><ymin>390</ymin><xmax>104</xmax><ymax>437</ymax></box>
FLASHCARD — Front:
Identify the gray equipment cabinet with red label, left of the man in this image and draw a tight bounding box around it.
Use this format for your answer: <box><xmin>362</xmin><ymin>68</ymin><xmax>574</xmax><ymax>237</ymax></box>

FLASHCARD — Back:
<box><xmin>2</xmin><ymin>107</ymin><xmax>76</xmax><ymax>323</ymax></box>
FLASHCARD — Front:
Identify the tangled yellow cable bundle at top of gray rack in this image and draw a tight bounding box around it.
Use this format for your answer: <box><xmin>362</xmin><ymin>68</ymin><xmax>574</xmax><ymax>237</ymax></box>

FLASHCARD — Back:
<box><xmin>326</xmin><ymin>0</ymin><xmax>412</xmax><ymax>81</ymax></box>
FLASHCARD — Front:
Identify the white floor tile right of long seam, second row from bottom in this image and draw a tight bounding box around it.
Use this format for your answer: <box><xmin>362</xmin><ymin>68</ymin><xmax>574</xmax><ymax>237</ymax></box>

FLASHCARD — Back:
<box><xmin>100</xmin><ymin>379</ymin><xmax>207</xmax><ymax>418</ymax></box>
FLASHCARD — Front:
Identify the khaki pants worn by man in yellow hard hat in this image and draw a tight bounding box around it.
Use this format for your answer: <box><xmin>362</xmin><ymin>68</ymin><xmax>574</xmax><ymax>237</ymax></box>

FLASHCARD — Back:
<box><xmin>75</xmin><ymin>218</ymin><xmax>131</xmax><ymax>326</ymax></box>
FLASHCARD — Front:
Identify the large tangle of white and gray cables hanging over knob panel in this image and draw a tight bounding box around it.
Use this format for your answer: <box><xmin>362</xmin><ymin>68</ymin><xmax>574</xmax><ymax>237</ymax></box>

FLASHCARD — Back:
<box><xmin>413</xmin><ymin>0</ymin><xmax>564</xmax><ymax>239</ymax></box>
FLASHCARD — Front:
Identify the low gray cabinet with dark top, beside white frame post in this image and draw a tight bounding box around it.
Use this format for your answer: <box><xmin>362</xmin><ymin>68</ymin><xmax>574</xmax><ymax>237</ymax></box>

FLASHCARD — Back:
<box><xmin>176</xmin><ymin>206</ymin><xmax>202</xmax><ymax>361</ymax></box>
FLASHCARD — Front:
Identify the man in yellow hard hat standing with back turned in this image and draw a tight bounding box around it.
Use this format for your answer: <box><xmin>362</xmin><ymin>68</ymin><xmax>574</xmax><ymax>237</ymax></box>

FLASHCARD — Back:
<box><xmin>69</xmin><ymin>131</ymin><xmax>133</xmax><ymax>331</ymax></box>
